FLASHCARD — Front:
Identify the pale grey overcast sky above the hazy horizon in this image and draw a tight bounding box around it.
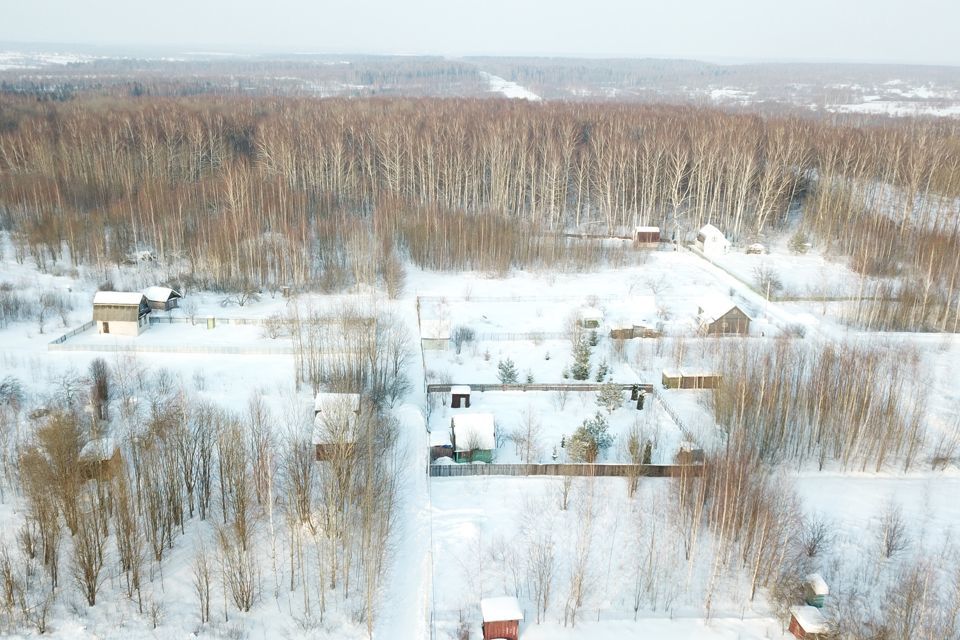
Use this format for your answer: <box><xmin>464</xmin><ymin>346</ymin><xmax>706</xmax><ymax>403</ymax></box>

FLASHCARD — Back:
<box><xmin>0</xmin><ymin>0</ymin><xmax>960</xmax><ymax>65</ymax></box>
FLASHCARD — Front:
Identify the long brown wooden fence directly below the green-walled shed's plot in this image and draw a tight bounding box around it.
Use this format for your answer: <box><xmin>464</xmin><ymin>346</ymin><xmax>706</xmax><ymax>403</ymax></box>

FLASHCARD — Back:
<box><xmin>430</xmin><ymin>463</ymin><xmax>703</xmax><ymax>478</ymax></box>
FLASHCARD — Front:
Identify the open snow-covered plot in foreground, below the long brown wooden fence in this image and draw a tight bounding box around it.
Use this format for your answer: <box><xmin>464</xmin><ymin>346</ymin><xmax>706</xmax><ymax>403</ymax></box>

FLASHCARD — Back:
<box><xmin>431</xmin><ymin>477</ymin><xmax>788</xmax><ymax>640</ymax></box>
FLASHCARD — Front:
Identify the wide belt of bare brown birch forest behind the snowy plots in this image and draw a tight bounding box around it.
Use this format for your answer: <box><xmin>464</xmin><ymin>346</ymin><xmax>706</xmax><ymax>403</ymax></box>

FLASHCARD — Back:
<box><xmin>0</xmin><ymin>95</ymin><xmax>960</xmax><ymax>327</ymax></box>
